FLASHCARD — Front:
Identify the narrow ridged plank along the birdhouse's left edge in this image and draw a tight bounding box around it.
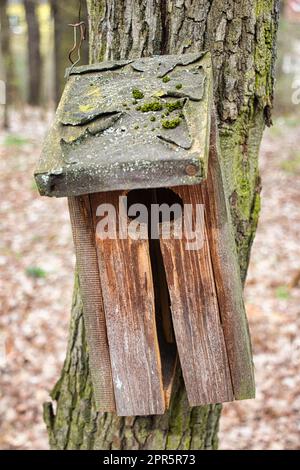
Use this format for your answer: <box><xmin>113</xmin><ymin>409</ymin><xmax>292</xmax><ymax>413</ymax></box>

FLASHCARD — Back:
<box><xmin>69</xmin><ymin>196</ymin><xmax>115</xmax><ymax>412</ymax></box>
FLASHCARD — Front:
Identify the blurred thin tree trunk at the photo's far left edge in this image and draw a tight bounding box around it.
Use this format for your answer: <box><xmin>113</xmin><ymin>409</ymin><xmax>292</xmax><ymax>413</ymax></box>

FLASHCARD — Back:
<box><xmin>0</xmin><ymin>0</ymin><xmax>13</xmax><ymax>129</ymax></box>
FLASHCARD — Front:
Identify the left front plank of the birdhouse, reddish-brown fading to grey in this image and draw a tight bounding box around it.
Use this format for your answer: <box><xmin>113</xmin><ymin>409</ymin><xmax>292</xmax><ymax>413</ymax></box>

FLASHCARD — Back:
<box><xmin>91</xmin><ymin>192</ymin><xmax>165</xmax><ymax>416</ymax></box>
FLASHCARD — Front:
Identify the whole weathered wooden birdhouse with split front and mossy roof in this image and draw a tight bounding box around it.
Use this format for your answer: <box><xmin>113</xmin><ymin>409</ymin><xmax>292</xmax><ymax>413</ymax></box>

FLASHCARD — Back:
<box><xmin>35</xmin><ymin>53</ymin><xmax>254</xmax><ymax>416</ymax></box>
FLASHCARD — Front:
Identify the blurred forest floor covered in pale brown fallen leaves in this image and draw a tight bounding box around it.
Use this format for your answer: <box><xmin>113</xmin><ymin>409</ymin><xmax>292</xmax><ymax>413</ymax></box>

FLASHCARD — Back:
<box><xmin>0</xmin><ymin>110</ymin><xmax>300</xmax><ymax>450</ymax></box>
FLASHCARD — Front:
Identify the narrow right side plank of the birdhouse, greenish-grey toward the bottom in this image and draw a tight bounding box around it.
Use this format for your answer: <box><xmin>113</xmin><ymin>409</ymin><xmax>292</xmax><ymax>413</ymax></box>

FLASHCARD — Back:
<box><xmin>201</xmin><ymin>117</ymin><xmax>255</xmax><ymax>400</ymax></box>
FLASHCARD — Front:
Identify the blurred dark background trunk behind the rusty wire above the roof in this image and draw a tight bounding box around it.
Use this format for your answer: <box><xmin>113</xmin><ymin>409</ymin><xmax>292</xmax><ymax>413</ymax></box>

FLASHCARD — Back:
<box><xmin>50</xmin><ymin>0</ymin><xmax>88</xmax><ymax>103</ymax></box>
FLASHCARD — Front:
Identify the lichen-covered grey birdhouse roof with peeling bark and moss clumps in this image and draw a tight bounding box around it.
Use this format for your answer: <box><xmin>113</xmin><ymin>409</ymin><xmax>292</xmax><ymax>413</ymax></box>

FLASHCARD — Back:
<box><xmin>35</xmin><ymin>53</ymin><xmax>213</xmax><ymax>197</ymax></box>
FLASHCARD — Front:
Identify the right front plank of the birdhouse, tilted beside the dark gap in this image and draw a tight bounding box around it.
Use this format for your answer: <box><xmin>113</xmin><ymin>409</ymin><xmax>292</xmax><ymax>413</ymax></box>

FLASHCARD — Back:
<box><xmin>160</xmin><ymin>186</ymin><xmax>233</xmax><ymax>406</ymax></box>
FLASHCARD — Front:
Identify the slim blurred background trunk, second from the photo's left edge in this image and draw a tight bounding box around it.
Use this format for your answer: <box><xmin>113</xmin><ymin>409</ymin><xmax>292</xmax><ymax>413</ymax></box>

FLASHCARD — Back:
<box><xmin>24</xmin><ymin>0</ymin><xmax>42</xmax><ymax>106</ymax></box>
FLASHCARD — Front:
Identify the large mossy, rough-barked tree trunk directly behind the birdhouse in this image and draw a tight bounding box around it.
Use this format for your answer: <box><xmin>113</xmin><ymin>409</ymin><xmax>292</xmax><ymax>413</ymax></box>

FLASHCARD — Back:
<box><xmin>44</xmin><ymin>0</ymin><xmax>279</xmax><ymax>450</ymax></box>
